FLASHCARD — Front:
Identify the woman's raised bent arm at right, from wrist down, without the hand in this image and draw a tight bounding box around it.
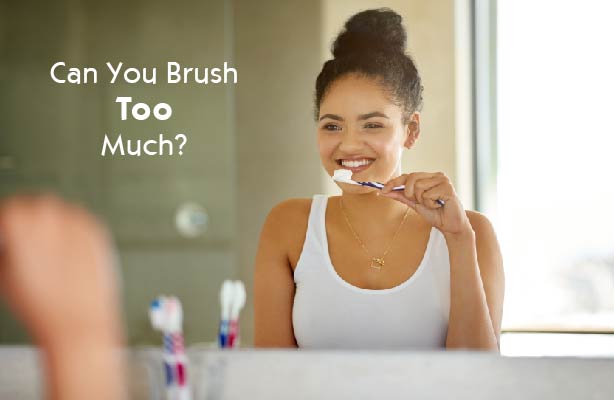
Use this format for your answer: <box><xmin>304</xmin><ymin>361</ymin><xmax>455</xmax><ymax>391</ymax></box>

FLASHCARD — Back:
<box><xmin>444</xmin><ymin>211</ymin><xmax>505</xmax><ymax>352</ymax></box>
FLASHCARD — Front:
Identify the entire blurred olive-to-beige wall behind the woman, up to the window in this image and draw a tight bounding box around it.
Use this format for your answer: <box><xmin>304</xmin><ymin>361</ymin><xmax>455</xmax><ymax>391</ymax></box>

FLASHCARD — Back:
<box><xmin>0</xmin><ymin>0</ymin><xmax>471</xmax><ymax>345</ymax></box>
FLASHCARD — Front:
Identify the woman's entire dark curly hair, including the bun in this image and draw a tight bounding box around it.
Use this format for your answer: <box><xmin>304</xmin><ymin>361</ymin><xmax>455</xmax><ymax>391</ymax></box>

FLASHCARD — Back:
<box><xmin>314</xmin><ymin>8</ymin><xmax>424</xmax><ymax>123</ymax></box>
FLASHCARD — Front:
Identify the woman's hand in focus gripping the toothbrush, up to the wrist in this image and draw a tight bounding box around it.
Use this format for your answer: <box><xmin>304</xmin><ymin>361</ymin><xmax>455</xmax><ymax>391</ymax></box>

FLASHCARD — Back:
<box><xmin>380</xmin><ymin>172</ymin><xmax>472</xmax><ymax>235</ymax></box>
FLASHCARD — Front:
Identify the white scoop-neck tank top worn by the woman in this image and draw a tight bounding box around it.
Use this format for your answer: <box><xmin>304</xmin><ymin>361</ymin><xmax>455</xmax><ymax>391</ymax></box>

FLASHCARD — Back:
<box><xmin>292</xmin><ymin>194</ymin><xmax>450</xmax><ymax>350</ymax></box>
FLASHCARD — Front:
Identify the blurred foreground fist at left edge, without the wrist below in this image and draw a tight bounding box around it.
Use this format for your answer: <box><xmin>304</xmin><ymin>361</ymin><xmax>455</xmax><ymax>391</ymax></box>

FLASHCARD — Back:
<box><xmin>0</xmin><ymin>195</ymin><xmax>119</xmax><ymax>344</ymax></box>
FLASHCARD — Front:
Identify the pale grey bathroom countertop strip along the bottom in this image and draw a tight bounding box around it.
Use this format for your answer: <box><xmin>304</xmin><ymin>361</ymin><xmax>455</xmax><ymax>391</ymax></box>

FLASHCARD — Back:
<box><xmin>0</xmin><ymin>346</ymin><xmax>614</xmax><ymax>400</ymax></box>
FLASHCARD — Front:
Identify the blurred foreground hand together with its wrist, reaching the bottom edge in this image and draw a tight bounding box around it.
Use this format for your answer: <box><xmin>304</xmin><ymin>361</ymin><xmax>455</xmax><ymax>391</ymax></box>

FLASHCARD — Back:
<box><xmin>0</xmin><ymin>195</ymin><xmax>127</xmax><ymax>400</ymax></box>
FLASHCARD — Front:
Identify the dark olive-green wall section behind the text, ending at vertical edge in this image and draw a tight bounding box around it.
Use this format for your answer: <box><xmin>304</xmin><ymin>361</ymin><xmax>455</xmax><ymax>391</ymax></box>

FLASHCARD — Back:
<box><xmin>0</xmin><ymin>0</ymin><xmax>241</xmax><ymax>344</ymax></box>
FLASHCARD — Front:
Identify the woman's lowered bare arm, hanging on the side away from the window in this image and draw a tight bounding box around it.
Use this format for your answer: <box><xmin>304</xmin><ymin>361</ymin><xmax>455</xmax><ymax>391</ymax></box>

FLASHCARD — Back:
<box><xmin>254</xmin><ymin>200</ymin><xmax>297</xmax><ymax>347</ymax></box>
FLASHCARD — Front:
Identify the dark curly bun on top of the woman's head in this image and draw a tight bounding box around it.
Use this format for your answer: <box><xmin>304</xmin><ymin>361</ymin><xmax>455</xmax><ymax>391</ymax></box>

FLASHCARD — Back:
<box><xmin>332</xmin><ymin>8</ymin><xmax>407</xmax><ymax>58</ymax></box>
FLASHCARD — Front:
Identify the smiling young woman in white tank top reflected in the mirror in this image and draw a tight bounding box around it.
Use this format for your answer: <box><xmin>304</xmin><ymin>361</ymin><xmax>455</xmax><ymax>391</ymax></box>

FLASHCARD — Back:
<box><xmin>254</xmin><ymin>9</ymin><xmax>504</xmax><ymax>351</ymax></box>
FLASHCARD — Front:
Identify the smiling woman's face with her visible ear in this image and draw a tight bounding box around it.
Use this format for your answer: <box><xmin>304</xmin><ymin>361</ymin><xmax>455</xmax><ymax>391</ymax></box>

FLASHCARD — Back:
<box><xmin>318</xmin><ymin>75</ymin><xmax>419</xmax><ymax>193</ymax></box>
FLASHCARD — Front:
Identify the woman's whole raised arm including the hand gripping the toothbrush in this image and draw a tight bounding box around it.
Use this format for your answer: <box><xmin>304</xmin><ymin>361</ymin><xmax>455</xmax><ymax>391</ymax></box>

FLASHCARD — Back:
<box><xmin>381</xmin><ymin>172</ymin><xmax>505</xmax><ymax>351</ymax></box>
